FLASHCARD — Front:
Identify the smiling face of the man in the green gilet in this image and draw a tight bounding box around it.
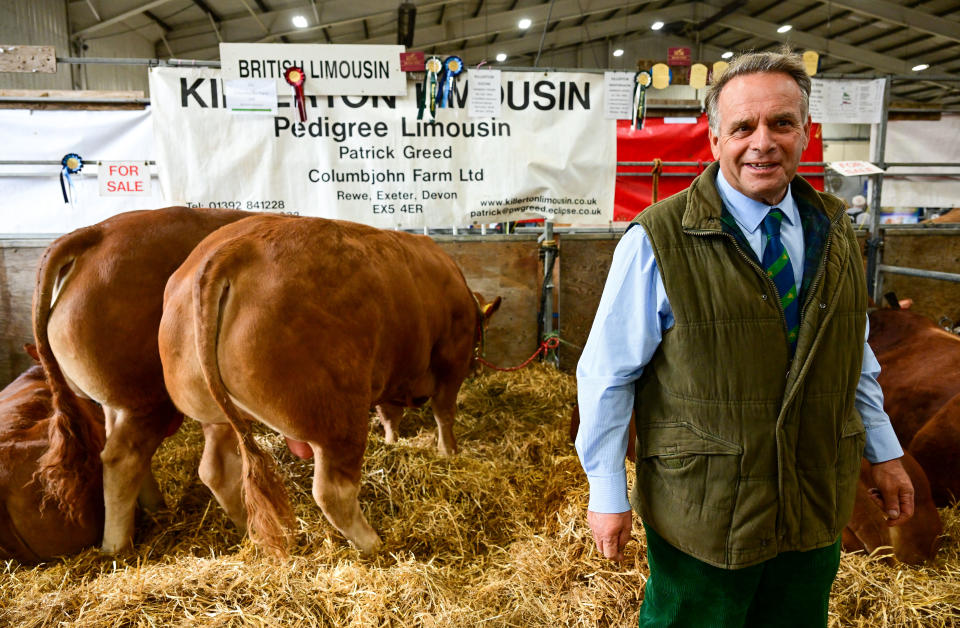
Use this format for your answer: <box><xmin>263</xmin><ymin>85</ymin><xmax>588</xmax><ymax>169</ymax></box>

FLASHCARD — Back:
<box><xmin>709</xmin><ymin>72</ymin><xmax>810</xmax><ymax>205</ymax></box>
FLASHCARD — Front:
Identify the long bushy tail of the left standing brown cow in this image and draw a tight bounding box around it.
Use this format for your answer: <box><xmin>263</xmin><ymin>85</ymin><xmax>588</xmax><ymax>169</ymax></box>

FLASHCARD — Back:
<box><xmin>33</xmin><ymin>227</ymin><xmax>103</xmax><ymax>524</ymax></box>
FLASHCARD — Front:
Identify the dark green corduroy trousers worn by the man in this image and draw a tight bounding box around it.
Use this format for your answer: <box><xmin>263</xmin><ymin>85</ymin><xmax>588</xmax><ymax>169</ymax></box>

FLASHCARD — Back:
<box><xmin>639</xmin><ymin>525</ymin><xmax>840</xmax><ymax>628</ymax></box>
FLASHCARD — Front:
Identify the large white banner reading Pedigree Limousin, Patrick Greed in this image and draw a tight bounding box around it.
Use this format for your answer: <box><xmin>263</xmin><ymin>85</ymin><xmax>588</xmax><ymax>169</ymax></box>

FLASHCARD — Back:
<box><xmin>150</xmin><ymin>68</ymin><xmax>617</xmax><ymax>228</ymax></box>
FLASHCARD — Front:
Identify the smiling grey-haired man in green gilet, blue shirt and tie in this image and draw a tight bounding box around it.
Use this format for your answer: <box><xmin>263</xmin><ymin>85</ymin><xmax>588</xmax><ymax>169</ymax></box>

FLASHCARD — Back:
<box><xmin>577</xmin><ymin>50</ymin><xmax>913</xmax><ymax>628</ymax></box>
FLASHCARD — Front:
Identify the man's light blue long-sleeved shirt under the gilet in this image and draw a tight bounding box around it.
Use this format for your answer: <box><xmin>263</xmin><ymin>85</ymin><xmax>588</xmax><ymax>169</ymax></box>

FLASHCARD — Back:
<box><xmin>576</xmin><ymin>174</ymin><xmax>903</xmax><ymax>513</ymax></box>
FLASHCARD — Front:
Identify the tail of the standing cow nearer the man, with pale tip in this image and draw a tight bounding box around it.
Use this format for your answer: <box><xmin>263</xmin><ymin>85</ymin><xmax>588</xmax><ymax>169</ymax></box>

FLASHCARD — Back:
<box><xmin>193</xmin><ymin>254</ymin><xmax>294</xmax><ymax>556</ymax></box>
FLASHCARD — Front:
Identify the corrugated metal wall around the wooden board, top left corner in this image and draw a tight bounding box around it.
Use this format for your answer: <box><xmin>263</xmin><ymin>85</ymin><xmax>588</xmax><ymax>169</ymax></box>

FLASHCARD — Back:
<box><xmin>0</xmin><ymin>0</ymin><xmax>71</xmax><ymax>89</ymax></box>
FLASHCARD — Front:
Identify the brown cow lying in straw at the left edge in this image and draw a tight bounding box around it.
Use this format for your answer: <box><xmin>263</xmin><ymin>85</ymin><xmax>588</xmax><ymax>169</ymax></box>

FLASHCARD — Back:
<box><xmin>0</xmin><ymin>349</ymin><xmax>103</xmax><ymax>563</ymax></box>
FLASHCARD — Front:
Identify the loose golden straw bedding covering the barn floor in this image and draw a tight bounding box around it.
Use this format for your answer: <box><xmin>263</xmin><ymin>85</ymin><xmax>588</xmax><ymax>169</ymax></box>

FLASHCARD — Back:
<box><xmin>0</xmin><ymin>366</ymin><xmax>960</xmax><ymax>628</ymax></box>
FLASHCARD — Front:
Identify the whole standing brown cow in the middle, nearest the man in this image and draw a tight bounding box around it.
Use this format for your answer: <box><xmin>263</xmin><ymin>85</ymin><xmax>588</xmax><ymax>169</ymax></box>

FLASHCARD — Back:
<box><xmin>159</xmin><ymin>216</ymin><xmax>500</xmax><ymax>553</ymax></box>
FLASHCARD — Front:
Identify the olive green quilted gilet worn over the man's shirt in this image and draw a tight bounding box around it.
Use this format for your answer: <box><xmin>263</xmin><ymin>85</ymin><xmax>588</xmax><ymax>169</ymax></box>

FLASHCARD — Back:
<box><xmin>630</xmin><ymin>163</ymin><xmax>867</xmax><ymax>568</ymax></box>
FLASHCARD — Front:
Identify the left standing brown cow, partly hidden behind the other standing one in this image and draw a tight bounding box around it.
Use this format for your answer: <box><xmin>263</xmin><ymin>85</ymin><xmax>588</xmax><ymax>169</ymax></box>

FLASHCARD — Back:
<box><xmin>33</xmin><ymin>207</ymin><xmax>251</xmax><ymax>552</ymax></box>
